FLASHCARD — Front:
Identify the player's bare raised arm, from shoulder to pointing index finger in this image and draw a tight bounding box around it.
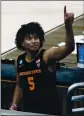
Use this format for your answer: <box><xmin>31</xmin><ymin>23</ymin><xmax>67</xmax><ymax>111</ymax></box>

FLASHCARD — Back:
<box><xmin>43</xmin><ymin>6</ymin><xmax>74</xmax><ymax>63</ymax></box>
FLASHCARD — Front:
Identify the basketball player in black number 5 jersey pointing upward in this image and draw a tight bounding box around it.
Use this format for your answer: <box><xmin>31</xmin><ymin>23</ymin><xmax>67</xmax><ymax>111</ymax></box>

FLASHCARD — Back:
<box><xmin>10</xmin><ymin>6</ymin><xmax>74</xmax><ymax>114</ymax></box>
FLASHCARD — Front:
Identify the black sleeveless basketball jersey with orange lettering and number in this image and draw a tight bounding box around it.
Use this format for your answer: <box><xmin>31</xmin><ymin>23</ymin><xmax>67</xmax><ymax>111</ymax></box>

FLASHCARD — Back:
<box><xmin>17</xmin><ymin>50</ymin><xmax>59</xmax><ymax>113</ymax></box>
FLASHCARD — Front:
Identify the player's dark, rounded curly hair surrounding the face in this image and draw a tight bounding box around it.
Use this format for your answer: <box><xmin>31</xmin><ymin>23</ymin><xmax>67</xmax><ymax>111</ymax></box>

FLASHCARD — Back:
<box><xmin>15</xmin><ymin>22</ymin><xmax>45</xmax><ymax>51</ymax></box>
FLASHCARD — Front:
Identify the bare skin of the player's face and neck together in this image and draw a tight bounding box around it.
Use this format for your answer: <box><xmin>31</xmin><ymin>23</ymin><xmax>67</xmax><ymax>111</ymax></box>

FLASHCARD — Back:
<box><xmin>22</xmin><ymin>34</ymin><xmax>40</xmax><ymax>62</ymax></box>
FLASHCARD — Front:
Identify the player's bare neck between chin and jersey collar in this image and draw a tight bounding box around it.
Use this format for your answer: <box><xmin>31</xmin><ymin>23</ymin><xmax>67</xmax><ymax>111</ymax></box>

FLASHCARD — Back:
<box><xmin>25</xmin><ymin>50</ymin><xmax>40</xmax><ymax>62</ymax></box>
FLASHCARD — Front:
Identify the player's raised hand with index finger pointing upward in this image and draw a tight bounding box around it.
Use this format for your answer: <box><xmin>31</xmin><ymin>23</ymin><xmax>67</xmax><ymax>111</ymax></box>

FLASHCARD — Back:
<box><xmin>64</xmin><ymin>6</ymin><xmax>74</xmax><ymax>26</ymax></box>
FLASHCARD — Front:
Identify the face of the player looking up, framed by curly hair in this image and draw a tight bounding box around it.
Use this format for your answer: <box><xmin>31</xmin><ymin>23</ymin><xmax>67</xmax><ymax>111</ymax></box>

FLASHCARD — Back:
<box><xmin>22</xmin><ymin>34</ymin><xmax>40</xmax><ymax>51</ymax></box>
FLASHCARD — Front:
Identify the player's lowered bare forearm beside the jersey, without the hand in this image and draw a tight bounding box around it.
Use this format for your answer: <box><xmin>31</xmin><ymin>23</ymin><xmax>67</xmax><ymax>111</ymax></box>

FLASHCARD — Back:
<box><xmin>12</xmin><ymin>85</ymin><xmax>22</xmax><ymax>105</ymax></box>
